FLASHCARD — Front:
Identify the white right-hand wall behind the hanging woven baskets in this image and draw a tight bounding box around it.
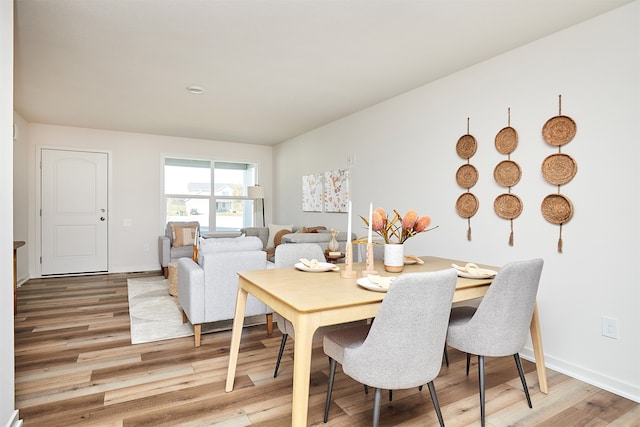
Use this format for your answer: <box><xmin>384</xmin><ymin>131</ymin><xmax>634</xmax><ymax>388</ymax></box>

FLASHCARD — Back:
<box><xmin>273</xmin><ymin>1</ymin><xmax>640</xmax><ymax>401</ymax></box>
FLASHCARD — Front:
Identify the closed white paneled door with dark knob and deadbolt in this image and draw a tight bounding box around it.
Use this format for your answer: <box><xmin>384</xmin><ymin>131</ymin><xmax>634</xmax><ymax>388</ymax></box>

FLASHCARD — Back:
<box><xmin>40</xmin><ymin>149</ymin><xmax>109</xmax><ymax>275</ymax></box>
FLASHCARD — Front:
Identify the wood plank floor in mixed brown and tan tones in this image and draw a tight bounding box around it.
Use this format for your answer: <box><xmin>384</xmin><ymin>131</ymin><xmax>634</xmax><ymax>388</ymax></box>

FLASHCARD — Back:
<box><xmin>15</xmin><ymin>274</ymin><xmax>640</xmax><ymax>427</ymax></box>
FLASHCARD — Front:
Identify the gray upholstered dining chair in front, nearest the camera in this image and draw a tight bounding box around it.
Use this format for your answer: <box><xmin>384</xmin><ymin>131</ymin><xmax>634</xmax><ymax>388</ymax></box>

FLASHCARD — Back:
<box><xmin>323</xmin><ymin>269</ymin><xmax>457</xmax><ymax>426</ymax></box>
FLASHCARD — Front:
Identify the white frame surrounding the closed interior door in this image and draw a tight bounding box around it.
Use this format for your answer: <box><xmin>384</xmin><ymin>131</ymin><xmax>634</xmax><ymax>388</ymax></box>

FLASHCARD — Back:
<box><xmin>32</xmin><ymin>145</ymin><xmax>113</xmax><ymax>277</ymax></box>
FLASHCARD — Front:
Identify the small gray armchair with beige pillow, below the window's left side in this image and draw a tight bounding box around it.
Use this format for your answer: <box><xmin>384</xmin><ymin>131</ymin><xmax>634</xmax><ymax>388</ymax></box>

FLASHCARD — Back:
<box><xmin>158</xmin><ymin>221</ymin><xmax>200</xmax><ymax>279</ymax></box>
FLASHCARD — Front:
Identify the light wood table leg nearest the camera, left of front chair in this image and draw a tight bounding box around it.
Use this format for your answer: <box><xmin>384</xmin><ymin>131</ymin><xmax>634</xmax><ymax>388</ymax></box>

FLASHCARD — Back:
<box><xmin>291</xmin><ymin>316</ymin><xmax>317</xmax><ymax>427</ymax></box>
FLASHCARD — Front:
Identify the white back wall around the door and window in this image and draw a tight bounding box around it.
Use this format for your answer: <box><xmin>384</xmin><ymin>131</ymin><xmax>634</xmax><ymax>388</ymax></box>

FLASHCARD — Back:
<box><xmin>21</xmin><ymin>123</ymin><xmax>272</xmax><ymax>277</ymax></box>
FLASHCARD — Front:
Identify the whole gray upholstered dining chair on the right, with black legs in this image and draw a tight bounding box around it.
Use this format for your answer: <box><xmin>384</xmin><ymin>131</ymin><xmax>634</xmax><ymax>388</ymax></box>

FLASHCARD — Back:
<box><xmin>447</xmin><ymin>258</ymin><xmax>543</xmax><ymax>426</ymax></box>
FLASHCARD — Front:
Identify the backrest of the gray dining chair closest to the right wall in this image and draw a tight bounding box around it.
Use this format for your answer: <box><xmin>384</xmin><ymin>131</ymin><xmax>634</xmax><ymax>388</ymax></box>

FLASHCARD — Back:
<box><xmin>456</xmin><ymin>258</ymin><xmax>544</xmax><ymax>357</ymax></box>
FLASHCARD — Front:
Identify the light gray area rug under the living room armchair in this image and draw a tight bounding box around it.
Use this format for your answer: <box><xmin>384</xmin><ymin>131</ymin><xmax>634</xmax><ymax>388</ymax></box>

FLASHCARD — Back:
<box><xmin>127</xmin><ymin>276</ymin><xmax>265</xmax><ymax>344</ymax></box>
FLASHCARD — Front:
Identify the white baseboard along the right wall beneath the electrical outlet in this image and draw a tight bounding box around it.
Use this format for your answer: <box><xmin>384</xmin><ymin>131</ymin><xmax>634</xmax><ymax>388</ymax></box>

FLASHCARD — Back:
<box><xmin>520</xmin><ymin>348</ymin><xmax>640</xmax><ymax>403</ymax></box>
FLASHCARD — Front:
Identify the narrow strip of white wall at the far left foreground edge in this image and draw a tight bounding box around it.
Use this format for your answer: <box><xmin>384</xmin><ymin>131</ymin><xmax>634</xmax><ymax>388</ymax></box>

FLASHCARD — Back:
<box><xmin>0</xmin><ymin>0</ymin><xmax>17</xmax><ymax>426</ymax></box>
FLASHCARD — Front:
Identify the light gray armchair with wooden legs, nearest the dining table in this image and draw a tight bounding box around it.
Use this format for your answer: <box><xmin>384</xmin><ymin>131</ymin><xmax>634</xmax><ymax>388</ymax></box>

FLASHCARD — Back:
<box><xmin>178</xmin><ymin>237</ymin><xmax>273</xmax><ymax>347</ymax></box>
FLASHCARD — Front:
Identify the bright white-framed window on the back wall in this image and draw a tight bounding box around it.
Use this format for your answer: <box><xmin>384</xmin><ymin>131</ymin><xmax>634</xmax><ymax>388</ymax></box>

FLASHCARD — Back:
<box><xmin>163</xmin><ymin>157</ymin><xmax>256</xmax><ymax>233</ymax></box>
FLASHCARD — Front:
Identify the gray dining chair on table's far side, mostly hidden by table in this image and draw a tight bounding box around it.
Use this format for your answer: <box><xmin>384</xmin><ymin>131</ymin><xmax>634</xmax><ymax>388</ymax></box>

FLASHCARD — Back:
<box><xmin>273</xmin><ymin>243</ymin><xmax>366</xmax><ymax>378</ymax></box>
